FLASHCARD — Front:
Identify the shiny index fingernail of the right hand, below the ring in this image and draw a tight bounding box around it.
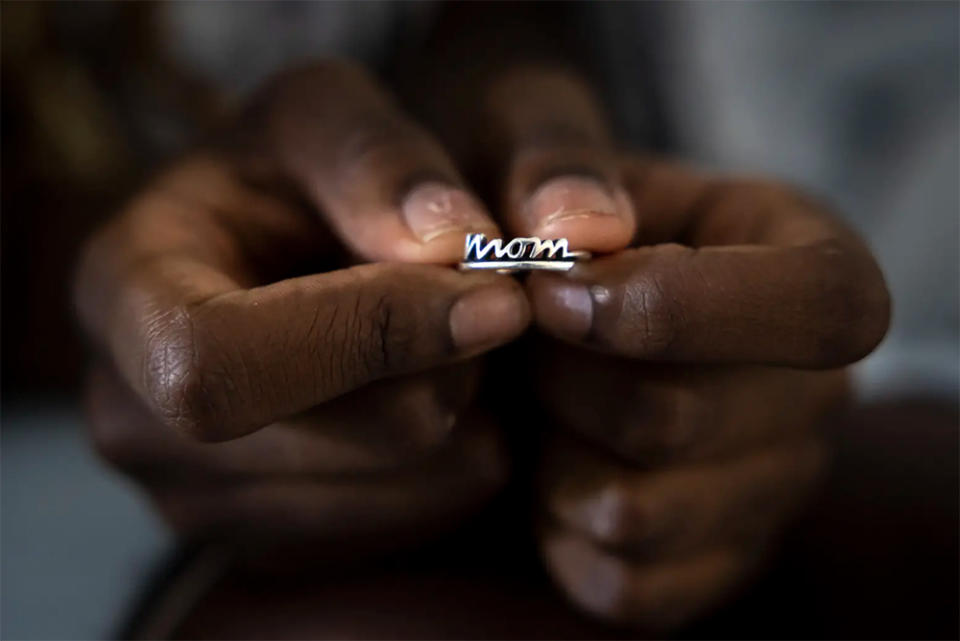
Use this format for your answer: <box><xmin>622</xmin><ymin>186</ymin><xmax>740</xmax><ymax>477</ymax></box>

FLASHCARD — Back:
<box><xmin>530</xmin><ymin>276</ymin><xmax>593</xmax><ymax>340</ymax></box>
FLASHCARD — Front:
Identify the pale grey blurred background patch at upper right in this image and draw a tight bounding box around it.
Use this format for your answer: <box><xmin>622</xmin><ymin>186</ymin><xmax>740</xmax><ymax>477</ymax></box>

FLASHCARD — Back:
<box><xmin>659</xmin><ymin>2</ymin><xmax>960</xmax><ymax>401</ymax></box>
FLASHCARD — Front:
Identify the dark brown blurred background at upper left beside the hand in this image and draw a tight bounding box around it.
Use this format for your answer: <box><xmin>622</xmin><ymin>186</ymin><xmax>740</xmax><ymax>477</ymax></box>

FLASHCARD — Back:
<box><xmin>0</xmin><ymin>2</ymin><xmax>217</xmax><ymax>400</ymax></box>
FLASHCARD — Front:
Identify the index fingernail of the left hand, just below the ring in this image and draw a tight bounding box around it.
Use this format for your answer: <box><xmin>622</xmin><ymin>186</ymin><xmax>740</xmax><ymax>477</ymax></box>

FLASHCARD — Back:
<box><xmin>450</xmin><ymin>285</ymin><xmax>530</xmax><ymax>351</ymax></box>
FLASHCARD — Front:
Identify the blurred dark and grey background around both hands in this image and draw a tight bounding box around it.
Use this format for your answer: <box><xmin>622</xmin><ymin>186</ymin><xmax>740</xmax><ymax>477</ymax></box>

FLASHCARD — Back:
<box><xmin>0</xmin><ymin>2</ymin><xmax>960</xmax><ymax>639</ymax></box>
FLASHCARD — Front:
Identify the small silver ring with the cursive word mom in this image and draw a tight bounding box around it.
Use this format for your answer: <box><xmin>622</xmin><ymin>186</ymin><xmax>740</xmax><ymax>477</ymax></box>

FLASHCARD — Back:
<box><xmin>462</xmin><ymin>234</ymin><xmax>576</xmax><ymax>271</ymax></box>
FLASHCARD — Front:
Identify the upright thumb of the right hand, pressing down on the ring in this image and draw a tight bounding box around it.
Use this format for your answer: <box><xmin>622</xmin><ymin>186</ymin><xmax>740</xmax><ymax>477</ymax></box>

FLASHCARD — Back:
<box><xmin>486</xmin><ymin>68</ymin><xmax>636</xmax><ymax>252</ymax></box>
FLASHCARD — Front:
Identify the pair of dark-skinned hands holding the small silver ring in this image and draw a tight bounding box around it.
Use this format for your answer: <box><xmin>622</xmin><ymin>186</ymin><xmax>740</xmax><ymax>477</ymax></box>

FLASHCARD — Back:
<box><xmin>76</xmin><ymin>63</ymin><xmax>889</xmax><ymax>625</ymax></box>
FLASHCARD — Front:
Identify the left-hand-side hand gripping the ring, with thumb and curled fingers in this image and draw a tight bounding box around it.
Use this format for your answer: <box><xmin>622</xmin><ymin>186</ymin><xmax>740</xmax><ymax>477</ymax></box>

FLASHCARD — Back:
<box><xmin>75</xmin><ymin>63</ymin><xmax>529</xmax><ymax>557</ymax></box>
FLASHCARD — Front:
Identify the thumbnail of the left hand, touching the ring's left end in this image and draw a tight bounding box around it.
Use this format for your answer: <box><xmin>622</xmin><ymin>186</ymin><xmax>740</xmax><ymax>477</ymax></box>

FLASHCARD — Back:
<box><xmin>401</xmin><ymin>182</ymin><xmax>494</xmax><ymax>243</ymax></box>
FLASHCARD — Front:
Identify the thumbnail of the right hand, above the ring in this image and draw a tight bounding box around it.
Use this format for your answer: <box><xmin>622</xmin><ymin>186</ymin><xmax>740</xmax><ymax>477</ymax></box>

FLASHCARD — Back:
<box><xmin>527</xmin><ymin>176</ymin><xmax>617</xmax><ymax>231</ymax></box>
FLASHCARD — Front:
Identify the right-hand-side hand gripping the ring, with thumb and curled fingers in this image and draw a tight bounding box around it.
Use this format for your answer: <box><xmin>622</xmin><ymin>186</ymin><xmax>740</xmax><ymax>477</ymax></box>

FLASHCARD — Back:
<box><xmin>462</xmin><ymin>69</ymin><xmax>889</xmax><ymax>630</ymax></box>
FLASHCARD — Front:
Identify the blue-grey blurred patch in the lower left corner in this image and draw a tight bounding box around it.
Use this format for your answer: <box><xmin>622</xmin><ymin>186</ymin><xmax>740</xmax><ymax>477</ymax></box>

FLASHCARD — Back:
<box><xmin>0</xmin><ymin>401</ymin><xmax>172</xmax><ymax>639</ymax></box>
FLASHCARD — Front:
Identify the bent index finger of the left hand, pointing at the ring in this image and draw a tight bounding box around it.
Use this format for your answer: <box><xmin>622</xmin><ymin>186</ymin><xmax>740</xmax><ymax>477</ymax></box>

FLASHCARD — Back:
<box><xmin>127</xmin><ymin>263</ymin><xmax>530</xmax><ymax>441</ymax></box>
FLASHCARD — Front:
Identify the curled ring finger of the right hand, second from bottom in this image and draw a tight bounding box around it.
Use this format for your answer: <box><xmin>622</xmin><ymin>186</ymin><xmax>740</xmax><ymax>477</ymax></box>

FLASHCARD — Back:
<box><xmin>544</xmin><ymin>438</ymin><xmax>824</xmax><ymax>557</ymax></box>
